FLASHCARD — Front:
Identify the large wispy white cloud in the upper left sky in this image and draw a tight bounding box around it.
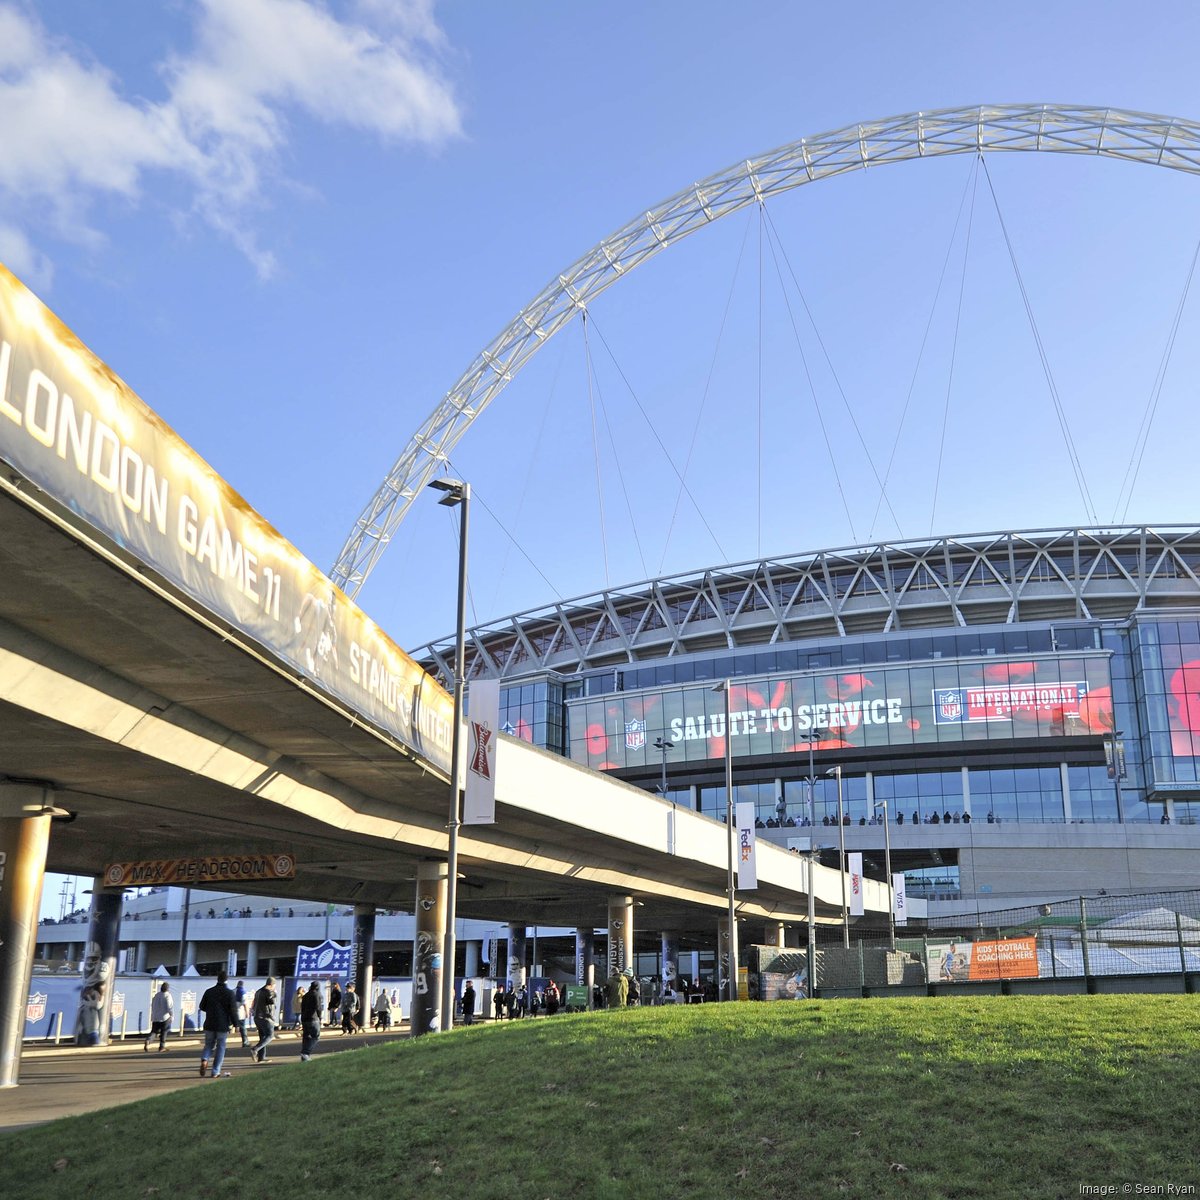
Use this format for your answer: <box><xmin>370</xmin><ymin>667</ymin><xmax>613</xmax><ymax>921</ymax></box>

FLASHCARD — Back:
<box><xmin>0</xmin><ymin>0</ymin><xmax>461</xmax><ymax>283</ymax></box>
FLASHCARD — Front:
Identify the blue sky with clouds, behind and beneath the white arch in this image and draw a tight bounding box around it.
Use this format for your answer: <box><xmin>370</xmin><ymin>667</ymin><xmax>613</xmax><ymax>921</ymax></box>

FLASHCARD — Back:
<box><xmin>7</xmin><ymin>0</ymin><xmax>1200</xmax><ymax>916</ymax></box>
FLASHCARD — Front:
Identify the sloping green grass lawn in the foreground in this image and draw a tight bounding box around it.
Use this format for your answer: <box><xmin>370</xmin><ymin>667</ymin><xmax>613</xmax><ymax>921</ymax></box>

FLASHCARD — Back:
<box><xmin>0</xmin><ymin>996</ymin><xmax>1200</xmax><ymax>1200</ymax></box>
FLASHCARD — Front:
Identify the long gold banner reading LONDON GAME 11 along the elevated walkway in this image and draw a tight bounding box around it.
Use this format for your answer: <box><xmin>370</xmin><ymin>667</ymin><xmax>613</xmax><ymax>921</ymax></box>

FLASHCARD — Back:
<box><xmin>0</xmin><ymin>266</ymin><xmax>452</xmax><ymax>770</ymax></box>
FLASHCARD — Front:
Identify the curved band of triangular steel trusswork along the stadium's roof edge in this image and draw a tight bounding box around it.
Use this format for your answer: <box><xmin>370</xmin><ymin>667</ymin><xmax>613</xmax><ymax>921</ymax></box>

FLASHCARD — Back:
<box><xmin>413</xmin><ymin>526</ymin><xmax>1200</xmax><ymax>678</ymax></box>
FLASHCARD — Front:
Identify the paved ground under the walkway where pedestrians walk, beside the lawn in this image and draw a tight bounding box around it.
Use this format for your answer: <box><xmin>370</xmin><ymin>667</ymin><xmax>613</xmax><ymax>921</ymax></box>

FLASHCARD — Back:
<box><xmin>0</xmin><ymin>1024</ymin><xmax>408</xmax><ymax>1135</ymax></box>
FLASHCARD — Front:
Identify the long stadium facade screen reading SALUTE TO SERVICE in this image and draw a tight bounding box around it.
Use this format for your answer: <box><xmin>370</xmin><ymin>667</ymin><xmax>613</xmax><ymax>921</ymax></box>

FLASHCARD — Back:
<box><xmin>568</xmin><ymin>653</ymin><xmax>1112</xmax><ymax>770</ymax></box>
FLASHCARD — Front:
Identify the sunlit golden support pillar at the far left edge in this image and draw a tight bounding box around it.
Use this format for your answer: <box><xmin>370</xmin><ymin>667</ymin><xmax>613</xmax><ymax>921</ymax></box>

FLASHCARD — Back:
<box><xmin>0</xmin><ymin>806</ymin><xmax>50</xmax><ymax>1087</ymax></box>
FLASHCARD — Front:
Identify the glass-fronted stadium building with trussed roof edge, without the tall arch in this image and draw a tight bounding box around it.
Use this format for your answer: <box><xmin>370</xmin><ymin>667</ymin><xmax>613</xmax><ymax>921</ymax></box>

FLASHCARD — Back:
<box><xmin>415</xmin><ymin>526</ymin><xmax>1200</xmax><ymax>918</ymax></box>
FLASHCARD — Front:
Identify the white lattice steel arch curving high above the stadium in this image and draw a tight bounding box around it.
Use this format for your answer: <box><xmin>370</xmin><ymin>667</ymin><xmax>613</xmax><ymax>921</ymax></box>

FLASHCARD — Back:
<box><xmin>330</xmin><ymin>104</ymin><xmax>1200</xmax><ymax>596</ymax></box>
